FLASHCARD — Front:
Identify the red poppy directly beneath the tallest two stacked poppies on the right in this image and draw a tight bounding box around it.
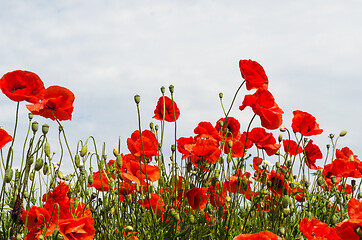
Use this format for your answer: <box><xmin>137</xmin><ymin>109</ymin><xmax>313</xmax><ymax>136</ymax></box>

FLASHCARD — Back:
<box><xmin>248</xmin><ymin>127</ymin><xmax>281</xmax><ymax>156</ymax></box>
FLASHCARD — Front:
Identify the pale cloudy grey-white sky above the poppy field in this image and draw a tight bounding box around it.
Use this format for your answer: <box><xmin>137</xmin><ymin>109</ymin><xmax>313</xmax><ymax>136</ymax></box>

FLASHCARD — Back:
<box><xmin>0</xmin><ymin>0</ymin><xmax>362</xmax><ymax>172</ymax></box>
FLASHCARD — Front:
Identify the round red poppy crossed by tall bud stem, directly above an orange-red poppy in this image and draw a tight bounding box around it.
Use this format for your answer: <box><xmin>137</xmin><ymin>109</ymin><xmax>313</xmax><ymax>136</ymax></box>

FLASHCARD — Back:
<box><xmin>127</xmin><ymin>130</ymin><xmax>158</xmax><ymax>160</ymax></box>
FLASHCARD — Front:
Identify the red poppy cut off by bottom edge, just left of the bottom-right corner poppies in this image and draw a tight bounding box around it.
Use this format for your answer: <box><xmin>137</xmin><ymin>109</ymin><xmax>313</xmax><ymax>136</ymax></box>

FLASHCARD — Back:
<box><xmin>299</xmin><ymin>218</ymin><xmax>341</xmax><ymax>240</ymax></box>
